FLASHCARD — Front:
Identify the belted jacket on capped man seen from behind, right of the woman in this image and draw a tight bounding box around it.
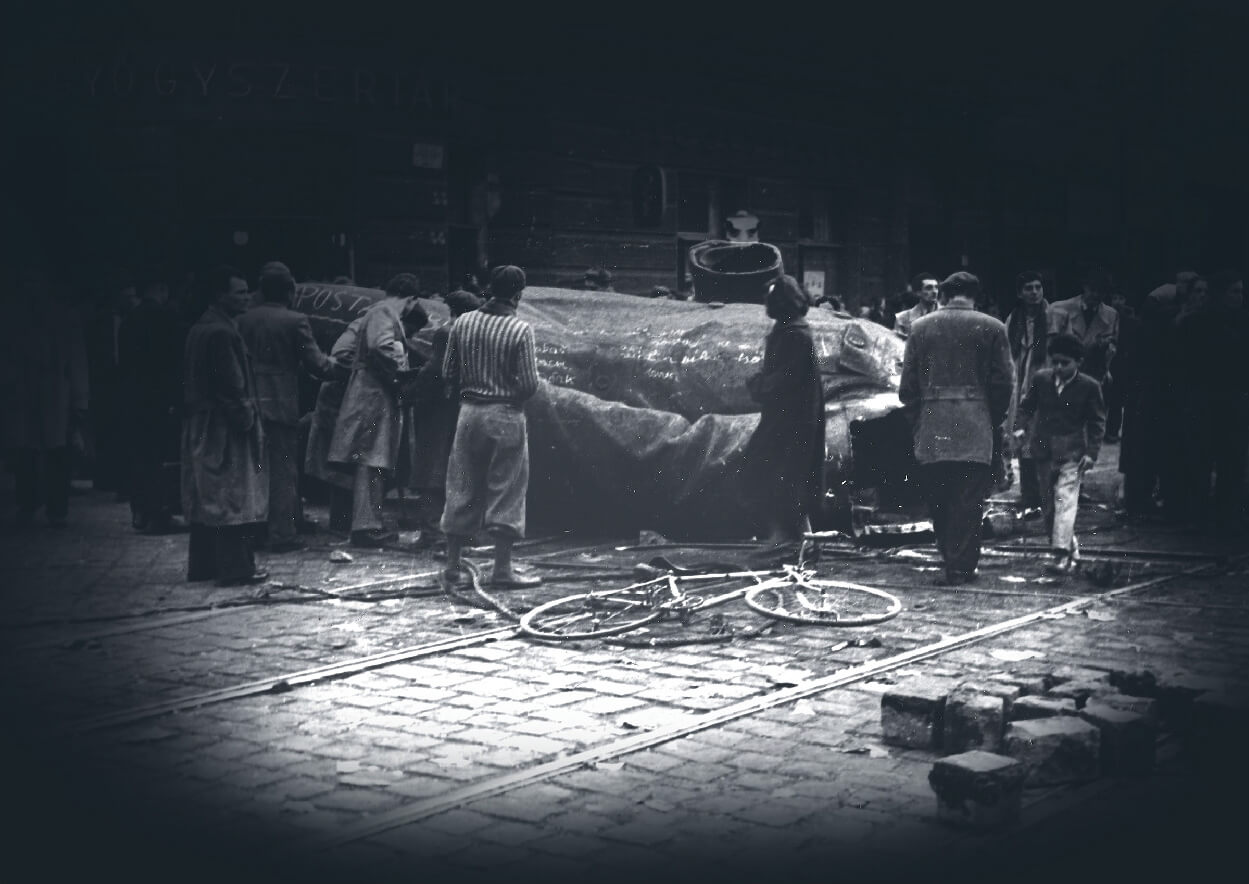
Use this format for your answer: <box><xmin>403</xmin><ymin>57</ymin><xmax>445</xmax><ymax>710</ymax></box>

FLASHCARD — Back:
<box><xmin>898</xmin><ymin>305</ymin><xmax>1013</xmax><ymax>464</ymax></box>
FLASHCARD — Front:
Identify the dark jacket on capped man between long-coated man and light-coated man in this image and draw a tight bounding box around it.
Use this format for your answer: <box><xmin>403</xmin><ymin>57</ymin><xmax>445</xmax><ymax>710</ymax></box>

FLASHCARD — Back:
<box><xmin>239</xmin><ymin>303</ymin><xmax>330</xmax><ymax>427</ymax></box>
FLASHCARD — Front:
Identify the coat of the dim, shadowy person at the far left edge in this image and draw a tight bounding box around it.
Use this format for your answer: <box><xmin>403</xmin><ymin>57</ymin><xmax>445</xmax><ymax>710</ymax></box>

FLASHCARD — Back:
<box><xmin>0</xmin><ymin>298</ymin><xmax>87</xmax><ymax>451</ymax></box>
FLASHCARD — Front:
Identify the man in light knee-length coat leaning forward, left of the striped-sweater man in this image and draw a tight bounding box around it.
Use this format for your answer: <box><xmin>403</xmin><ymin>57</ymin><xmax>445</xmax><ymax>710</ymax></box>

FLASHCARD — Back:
<box><xmin>328</xmin><ymin>273</ymin><xmax>428</xmax><ymax>547</ymax></box>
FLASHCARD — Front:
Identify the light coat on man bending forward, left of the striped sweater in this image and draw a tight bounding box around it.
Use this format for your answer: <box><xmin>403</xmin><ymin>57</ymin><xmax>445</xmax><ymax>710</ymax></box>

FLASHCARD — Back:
<box><xmin>330</xmin><ymin>297</ymin><xmax>407</xmax><ymax>469</ymax></box>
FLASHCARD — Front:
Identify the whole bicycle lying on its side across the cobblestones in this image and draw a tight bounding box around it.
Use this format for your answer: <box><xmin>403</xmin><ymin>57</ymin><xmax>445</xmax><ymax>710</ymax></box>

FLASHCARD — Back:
<box><xmin>520</xmin><ymin>534</ymin><xmax>902</xmax><ymax>642</ymax></box>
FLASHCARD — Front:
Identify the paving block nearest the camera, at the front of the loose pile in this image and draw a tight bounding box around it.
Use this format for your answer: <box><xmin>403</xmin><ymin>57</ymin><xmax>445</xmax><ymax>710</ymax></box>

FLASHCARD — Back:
<box><xmin>928</xmin><ymin>750</ymin><xmax>1024</xmax><ymax>830</ymax></box>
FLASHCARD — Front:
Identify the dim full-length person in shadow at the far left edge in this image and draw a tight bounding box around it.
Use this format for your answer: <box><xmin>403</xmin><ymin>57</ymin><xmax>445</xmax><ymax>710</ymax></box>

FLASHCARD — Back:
<box><xmin>0</xmin><ymin>270</ymin><xmax>89</xmax><ymax>529</ymax></box>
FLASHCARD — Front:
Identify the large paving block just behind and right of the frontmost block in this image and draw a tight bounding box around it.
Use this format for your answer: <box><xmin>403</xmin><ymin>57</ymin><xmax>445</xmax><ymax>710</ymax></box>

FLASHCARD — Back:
<box><xmin>1003</xmin><ymin>715</ymin><xmax>1102</xmax><ymax>785</ymax></box>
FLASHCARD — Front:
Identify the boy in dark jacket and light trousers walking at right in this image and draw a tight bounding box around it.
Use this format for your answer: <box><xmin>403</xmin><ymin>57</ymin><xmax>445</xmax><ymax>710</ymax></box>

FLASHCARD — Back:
<box><xmin>1019</xmin><ymin>333</ymin><xmax>1105</xmax><ymax>574</ymax></box>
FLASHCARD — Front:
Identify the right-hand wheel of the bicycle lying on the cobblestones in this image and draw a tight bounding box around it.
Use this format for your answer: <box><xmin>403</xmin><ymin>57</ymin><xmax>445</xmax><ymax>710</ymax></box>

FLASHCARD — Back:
<box><xmin>742</xmin><ymin>579</ymin><xmax>902</xmax><ymax>627</ymax></box>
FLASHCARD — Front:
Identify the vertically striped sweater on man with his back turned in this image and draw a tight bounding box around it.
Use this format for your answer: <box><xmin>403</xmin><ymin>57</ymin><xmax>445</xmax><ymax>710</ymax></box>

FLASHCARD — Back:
<box><xmin>442</xmin><ymin>310</ymin><xmax>538</xmax><ymax>406</ymax></box>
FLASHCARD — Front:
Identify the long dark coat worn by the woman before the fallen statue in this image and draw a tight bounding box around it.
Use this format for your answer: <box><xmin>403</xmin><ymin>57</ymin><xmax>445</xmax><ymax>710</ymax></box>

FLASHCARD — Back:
<box><xmin>747</xmin><ymin>320</ymin><xmax>824</xmax><ymax>514</ymax></box>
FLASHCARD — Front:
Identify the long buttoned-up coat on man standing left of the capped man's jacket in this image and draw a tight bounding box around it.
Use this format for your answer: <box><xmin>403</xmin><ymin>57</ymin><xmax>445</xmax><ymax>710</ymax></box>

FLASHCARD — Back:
<box><xmin>182</xmin><ymin>306</ymin><xmax>269</xmax><ymax>527</ymax></box>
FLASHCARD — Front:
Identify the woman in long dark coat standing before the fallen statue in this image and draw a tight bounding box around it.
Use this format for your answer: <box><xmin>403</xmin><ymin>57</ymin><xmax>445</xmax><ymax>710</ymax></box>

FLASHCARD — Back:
<box><xmin>746</xmin><ymin>276</ymin><xmax>824</xmax><ymax>543</ymax></box>
